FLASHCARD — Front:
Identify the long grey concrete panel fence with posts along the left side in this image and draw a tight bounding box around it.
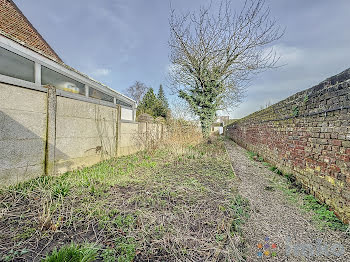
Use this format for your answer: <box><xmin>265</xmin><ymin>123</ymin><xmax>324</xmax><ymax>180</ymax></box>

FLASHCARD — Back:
<box><xmin>0</xmin><ymin>83</ymin><xmax>164</xmax><ymax>184</ymax></box>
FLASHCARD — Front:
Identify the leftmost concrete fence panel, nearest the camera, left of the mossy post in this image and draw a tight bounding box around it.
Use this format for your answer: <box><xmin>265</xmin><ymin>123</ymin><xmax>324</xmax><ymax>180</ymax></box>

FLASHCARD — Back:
<box><xmin>0</xmin><ymin>83</ymin><xmax>47</xmax><ymax>185</ymax></box>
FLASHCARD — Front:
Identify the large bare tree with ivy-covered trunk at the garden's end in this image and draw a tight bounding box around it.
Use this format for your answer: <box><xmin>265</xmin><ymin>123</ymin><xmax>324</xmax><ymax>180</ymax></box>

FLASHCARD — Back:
<box><xmin>169</xmin><ymin>0</ymin><xmax>283</xmax><ymax>136</ymax></box>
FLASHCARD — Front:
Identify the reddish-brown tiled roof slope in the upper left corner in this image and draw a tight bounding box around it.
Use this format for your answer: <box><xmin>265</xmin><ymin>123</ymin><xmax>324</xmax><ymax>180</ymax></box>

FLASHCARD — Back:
<box><xmin>0</xmin><ymin>0</ymin><xmax>62</xmax><ymax>62</ymax></box>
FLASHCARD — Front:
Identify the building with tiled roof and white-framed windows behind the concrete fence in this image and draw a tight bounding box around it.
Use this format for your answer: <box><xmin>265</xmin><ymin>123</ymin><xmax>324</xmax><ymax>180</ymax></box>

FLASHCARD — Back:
<box><xmin>0</xmin><ymin>0</ymin><xmax>136</xmax><ymax>120</ymax></box>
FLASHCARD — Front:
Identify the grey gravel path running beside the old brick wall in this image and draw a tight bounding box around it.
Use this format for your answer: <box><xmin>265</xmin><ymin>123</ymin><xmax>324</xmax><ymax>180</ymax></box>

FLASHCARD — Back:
<box><xmin>226</xmin><ymin>141</ymin><xmax>350</xmax><ymax>262</ymax></box>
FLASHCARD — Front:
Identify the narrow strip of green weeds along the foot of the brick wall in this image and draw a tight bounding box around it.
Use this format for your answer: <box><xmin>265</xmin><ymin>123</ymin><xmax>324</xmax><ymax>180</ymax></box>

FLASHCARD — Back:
<box><xmin>248</xmin><ymin>152</ymin><xmax>348</xmax><ymax>232</ymax></box>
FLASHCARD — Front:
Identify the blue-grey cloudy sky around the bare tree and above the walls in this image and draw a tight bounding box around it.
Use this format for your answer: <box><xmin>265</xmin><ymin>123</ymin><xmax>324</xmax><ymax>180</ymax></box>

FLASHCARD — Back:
<box><xmin>15</xmin><ymin>0</ymin><xmax>350</xmax><ymax>118</ymax></box>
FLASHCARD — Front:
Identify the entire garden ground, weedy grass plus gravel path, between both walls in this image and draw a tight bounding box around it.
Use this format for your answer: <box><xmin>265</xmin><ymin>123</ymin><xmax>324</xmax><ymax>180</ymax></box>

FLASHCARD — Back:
<box><xmin>0</xmin><ymin>138</ymin><xmax>350</xmax><ymax>261</ymax></box>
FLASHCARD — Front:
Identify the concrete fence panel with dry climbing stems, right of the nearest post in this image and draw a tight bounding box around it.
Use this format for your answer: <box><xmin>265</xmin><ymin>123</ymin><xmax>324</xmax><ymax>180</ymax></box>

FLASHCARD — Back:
<box><xmin>55</xmin><ymin>97</ymin><xmax>117</xmax><ymax>173</ymax></box>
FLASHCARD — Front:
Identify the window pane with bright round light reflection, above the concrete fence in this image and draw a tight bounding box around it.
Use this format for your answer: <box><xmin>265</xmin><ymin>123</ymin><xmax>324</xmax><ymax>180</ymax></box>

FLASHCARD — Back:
<box><xmin>41</xmin><ymin>66</ymin><xmax>85</xmax><ymax>95</ymax></box>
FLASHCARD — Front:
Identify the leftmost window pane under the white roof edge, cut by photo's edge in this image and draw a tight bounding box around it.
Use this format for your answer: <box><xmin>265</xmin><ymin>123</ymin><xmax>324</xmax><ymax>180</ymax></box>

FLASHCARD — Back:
<box><xmin>0</xmin><ymin>47</ymin><xmax>35</xmax><ymax>83</ymax></box>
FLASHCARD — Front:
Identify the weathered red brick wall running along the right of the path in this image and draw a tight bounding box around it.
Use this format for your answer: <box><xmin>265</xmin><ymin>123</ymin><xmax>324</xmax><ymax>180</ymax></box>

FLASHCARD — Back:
<box><xmin>225</xmin><ymin>69</ymin><xmax>350</xmax><ymax>223</ymax></box>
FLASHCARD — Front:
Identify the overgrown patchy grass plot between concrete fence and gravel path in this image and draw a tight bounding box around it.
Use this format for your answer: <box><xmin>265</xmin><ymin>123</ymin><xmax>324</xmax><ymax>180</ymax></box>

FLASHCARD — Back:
<box><xmin>0</xmin><ymin>139</ymin><xmax>249</xmax><ymax>261</ymax></box>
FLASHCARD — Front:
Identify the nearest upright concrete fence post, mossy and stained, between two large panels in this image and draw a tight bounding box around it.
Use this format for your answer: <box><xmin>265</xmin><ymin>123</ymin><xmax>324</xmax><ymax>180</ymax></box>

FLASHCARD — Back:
<box><xmin>44</xmin><ymin>86</ymin><xmax>57</xmax><ymax>175</ymax></box>
